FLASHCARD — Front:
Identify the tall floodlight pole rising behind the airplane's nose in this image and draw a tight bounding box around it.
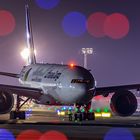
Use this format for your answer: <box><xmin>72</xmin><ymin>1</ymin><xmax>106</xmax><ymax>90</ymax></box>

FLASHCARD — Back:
<box><xmin>82</xmin><ymin>48</ymin><xmax>93</xmax><ymax>69</ymax></box>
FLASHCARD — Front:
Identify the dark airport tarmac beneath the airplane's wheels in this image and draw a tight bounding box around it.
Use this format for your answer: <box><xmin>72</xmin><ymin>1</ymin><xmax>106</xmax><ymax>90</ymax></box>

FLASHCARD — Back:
<box><xmin>0</xmin><ymin>111</ymin><xmax>140</xmax><ymax>140</ymax></box>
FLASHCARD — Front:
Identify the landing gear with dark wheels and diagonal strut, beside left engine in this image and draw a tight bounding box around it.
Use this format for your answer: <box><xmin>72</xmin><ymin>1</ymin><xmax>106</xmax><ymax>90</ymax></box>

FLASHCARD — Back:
<box><xmin>10</xmin><ymin>95</ymin><xmax>30</xmax><ymax>120</ymax></box>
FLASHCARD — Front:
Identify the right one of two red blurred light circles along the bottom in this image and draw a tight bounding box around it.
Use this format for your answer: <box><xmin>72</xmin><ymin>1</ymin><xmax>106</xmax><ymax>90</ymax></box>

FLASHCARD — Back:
<box><xmin>39</xmin><ymin>130</ymin><xmax>68</xmax><ymax>140</ymax></box>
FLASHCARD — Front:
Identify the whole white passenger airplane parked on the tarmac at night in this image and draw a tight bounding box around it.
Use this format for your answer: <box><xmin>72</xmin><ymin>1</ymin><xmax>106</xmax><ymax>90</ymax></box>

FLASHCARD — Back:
<box><xmin>0</xmin><ymin>3</ymin><xmax>140</xmax><ymax>120</ymax></box>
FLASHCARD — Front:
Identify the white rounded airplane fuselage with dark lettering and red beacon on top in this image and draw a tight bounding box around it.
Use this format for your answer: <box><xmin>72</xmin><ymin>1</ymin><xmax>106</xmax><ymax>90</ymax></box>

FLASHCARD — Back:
<box><xmin>19</xmin><ymin>64</ymin><xmax>95</xmax><ymax>104</ymax></box>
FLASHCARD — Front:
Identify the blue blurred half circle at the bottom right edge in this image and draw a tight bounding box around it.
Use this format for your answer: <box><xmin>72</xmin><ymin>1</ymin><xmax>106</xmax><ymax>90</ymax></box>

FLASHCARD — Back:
<box><xmin>104</xmin><ymin>128</ymin><xmax>135</xmax><ymax>140</ymax></box>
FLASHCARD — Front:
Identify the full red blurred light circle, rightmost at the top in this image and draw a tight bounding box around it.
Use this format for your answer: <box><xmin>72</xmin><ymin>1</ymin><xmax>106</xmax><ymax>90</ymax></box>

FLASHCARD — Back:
<box><xmin>104</xmin><ymin>13</ymin><xmax>129</xmax><ymax>39</ymax></box>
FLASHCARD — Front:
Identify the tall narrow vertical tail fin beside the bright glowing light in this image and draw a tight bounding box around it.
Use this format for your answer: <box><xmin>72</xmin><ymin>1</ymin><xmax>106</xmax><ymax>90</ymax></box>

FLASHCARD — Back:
<box><xmin>25</xmin><ymin>0</ymin><xmax>36</xmax><ymax>65</ymax></box>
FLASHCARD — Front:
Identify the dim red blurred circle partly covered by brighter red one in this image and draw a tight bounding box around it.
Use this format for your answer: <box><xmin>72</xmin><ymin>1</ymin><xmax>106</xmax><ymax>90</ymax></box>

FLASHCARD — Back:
<box><xmin>87</xmin><ymin>12</ymin><xmax>107</xmax><ymax>37</ymax></box>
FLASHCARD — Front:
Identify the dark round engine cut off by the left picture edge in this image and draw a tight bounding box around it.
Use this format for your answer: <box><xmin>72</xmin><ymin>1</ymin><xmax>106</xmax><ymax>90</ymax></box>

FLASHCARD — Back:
<box><xmin>0</xmin><ymin>91</ymin><xmax>14</xmax><ymax>114</ymax></box>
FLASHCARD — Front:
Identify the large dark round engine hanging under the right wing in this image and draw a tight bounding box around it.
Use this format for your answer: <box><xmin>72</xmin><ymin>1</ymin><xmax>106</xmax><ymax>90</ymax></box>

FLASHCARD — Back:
<box><xmin>110</xmin><ymin>90</ymin><xmax>137</xmax><ymax>117</ymax></box>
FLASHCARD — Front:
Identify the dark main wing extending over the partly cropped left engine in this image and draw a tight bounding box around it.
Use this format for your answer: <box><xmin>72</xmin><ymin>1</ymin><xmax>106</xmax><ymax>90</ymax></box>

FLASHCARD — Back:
<box><xmin>0</xmin><ymin>84</ymin><xmax>43</xmax><ymax>99</ymax></box>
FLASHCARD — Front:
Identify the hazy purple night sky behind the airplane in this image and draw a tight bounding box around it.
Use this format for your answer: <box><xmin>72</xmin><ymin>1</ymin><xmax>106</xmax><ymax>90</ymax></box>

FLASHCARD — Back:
<box><xmin>0</xmin><ymin>0</ymin><xmax>140</xmax><ymax>86</ymax></box>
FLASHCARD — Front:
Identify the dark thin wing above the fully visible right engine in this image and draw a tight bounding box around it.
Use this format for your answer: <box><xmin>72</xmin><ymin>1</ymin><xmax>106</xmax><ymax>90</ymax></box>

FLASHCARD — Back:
<box><xmin>94</xmin><ymin>84</ymin><xmax>140</xmax><ymax>96</ymax></box>
